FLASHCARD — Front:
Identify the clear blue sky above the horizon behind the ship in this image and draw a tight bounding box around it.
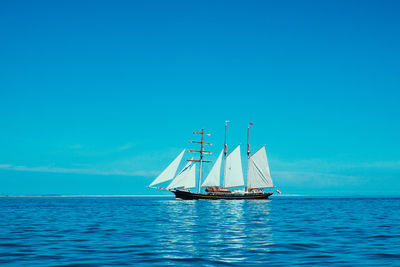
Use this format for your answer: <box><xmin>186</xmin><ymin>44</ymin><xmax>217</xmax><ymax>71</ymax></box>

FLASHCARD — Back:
<box><xmin>0</xmin><ymin>0</ymin><xmax>400</xmax><ymax>195</ymax></box>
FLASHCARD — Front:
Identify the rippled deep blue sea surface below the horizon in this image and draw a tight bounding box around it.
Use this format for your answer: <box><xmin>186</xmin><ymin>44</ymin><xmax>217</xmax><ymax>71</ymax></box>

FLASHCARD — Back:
<box><xmin>0</xmin><ymin>197</ymin><xmax>400</xmax><ymax>266</ymax></box>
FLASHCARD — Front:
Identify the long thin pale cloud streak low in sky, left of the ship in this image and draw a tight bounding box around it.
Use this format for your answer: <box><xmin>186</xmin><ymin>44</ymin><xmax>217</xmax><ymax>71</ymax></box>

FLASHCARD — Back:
<box><xmin>0</xmin><ymin>164</ymin><xmax>159</xmax><ymax>176</ymax></box>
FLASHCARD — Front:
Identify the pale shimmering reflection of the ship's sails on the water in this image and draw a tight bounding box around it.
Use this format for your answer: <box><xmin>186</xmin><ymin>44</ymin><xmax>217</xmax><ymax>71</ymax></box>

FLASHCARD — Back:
<box><xmin>158</xmin><ymin>200</ymin><xmax>273</xmax><ymax>263</ymax></box>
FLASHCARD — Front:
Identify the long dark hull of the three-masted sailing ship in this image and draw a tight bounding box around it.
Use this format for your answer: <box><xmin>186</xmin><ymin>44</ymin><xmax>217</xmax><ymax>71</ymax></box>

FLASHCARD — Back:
<box><xmin>172</xmin><ymin>190</ymin><xmax>272</xmax><ymax>199</ymax></box>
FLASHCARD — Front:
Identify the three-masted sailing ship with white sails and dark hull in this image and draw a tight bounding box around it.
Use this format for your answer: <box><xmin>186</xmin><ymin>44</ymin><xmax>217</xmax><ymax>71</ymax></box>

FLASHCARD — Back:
<box><xmin>149</xmin><ymin>121</ymin><xmax>274</xmax><ymax>199</ymax></box>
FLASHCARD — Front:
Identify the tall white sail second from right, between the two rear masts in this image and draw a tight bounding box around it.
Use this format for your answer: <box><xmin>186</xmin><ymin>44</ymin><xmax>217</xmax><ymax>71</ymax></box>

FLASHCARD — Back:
<box><xmin>224</xmin><ymin>145</ymin><xmax>244</xmax><ymax>187</ymax></box>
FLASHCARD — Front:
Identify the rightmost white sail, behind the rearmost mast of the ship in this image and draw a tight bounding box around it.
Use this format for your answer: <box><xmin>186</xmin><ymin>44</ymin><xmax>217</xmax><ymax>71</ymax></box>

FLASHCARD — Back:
<box><xmin>247</xmin><ymin>146</ymin><xmax>274</xmax><ymax>189</ymax></box>
